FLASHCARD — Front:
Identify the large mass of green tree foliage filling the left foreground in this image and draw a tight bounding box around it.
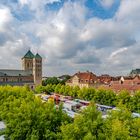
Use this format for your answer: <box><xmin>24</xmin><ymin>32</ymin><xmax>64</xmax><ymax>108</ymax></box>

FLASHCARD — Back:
<box><xmin>0</xmin><ymin>86</ymin><xmax>70</xmax><ymax>140</ymax></box>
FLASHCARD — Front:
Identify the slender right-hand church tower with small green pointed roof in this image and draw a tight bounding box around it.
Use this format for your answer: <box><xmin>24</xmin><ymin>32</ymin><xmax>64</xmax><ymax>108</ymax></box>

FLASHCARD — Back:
<box><xmin>33</xmin><ymin>53</ymin><xmax>42</xmax><ymax>85</ymax></box>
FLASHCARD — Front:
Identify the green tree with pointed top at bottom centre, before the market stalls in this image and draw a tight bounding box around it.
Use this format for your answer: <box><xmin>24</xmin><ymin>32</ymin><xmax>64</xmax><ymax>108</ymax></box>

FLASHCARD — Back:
<box><xmin>61</xmin><ymin>104</ymin><xmax>104</xmax><ymax>140</ymax></box>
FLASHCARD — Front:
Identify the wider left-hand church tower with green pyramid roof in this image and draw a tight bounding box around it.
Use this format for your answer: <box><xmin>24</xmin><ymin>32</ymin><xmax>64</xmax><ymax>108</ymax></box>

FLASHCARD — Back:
<box><xmin>22</xmin><ymin>50</ymin><xmax>34</xmax><ymax>71</ymax></box>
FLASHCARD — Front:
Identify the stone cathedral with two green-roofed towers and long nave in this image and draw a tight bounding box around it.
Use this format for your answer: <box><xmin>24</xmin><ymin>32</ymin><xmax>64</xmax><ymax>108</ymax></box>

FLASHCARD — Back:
<box><xmin>0</xmin><ymin>50</ymin><xmax>42</xmax><ymax>88</ymax></box>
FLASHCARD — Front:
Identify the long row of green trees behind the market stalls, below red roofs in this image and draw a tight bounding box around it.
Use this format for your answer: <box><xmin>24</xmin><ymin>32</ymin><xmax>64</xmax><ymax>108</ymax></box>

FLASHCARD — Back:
<box><xmin>36</xmin><ymin>84</ymin><xmax>140</xmax><ymax>113</ymax></box>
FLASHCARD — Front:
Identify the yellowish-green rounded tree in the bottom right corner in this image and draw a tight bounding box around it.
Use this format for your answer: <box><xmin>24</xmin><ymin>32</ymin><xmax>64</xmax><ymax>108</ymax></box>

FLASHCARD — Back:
<box><xmin>104</xmin><ymin>106</ymin><xmax>140</xmax><ymax>140</ymax></box>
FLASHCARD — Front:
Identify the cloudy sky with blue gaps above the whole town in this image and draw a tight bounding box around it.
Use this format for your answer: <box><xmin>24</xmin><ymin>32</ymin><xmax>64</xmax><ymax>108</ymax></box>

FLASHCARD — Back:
<box><xmin>0</xmin><ymin>0</ymin><xmax>140</xmax><ymax>76</ymax></box>
